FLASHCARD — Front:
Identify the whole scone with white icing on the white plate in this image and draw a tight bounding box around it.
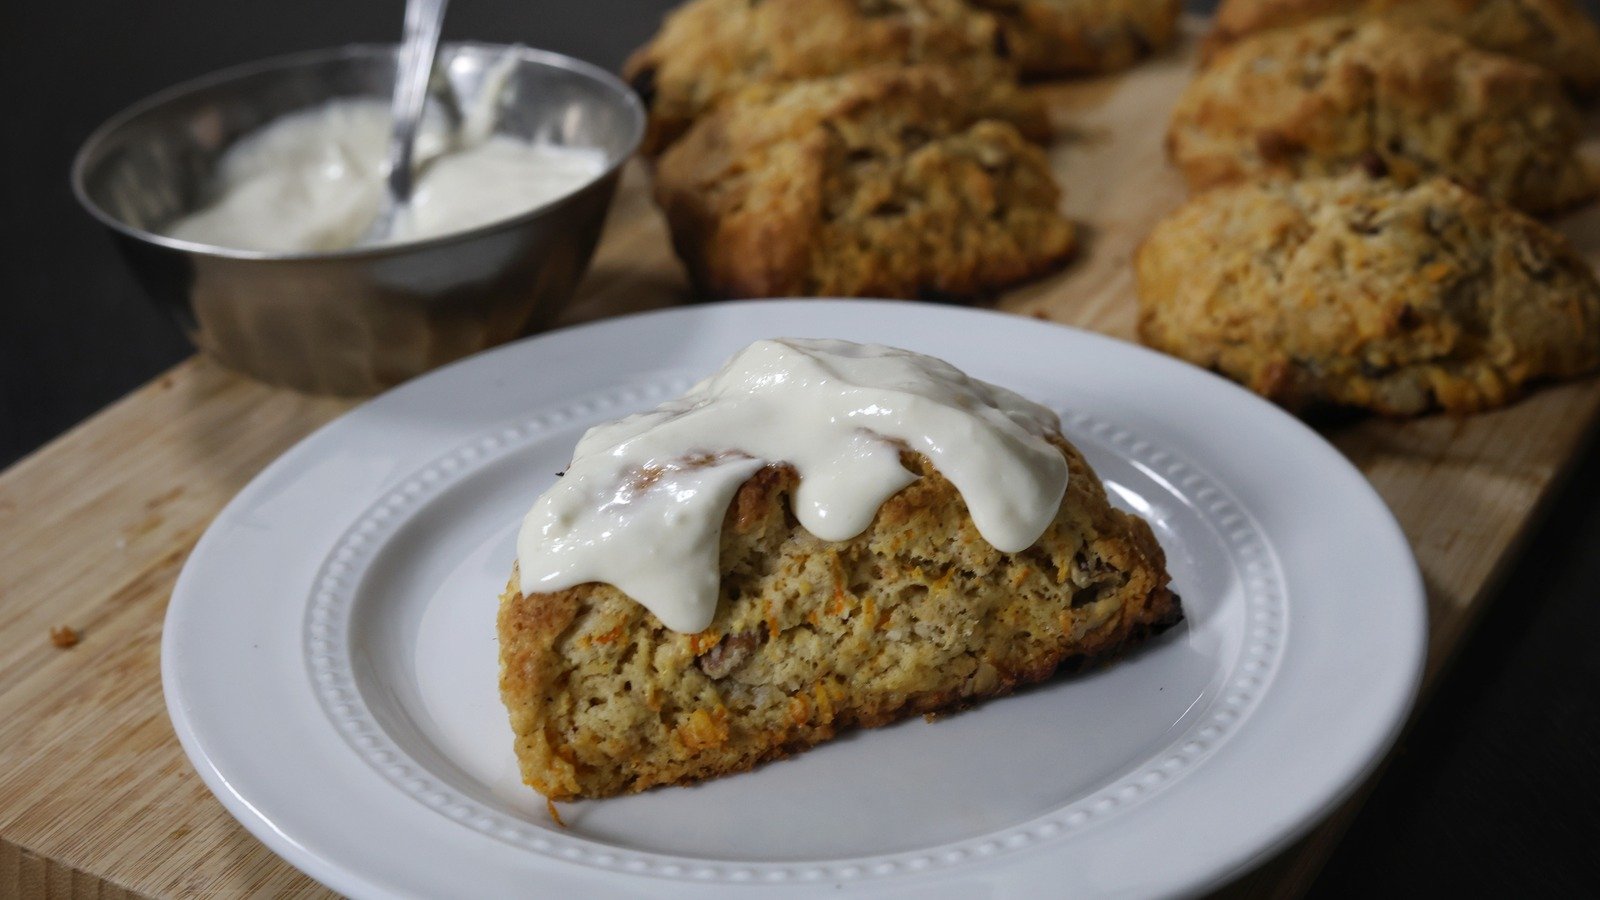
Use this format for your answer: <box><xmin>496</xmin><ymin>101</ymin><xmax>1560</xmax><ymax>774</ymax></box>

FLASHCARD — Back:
<box><xmin>499</xmin><ymin>341</ymin><xmax>1182</xmax><ymax>801</ymax></box>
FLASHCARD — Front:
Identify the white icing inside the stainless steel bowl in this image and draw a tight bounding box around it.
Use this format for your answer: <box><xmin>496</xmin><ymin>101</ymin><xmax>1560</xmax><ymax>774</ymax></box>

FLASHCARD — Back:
<box><xmin>166</xmin><ymin>91</ymin><xmax>605</xmax><ymax>253</ymax></box>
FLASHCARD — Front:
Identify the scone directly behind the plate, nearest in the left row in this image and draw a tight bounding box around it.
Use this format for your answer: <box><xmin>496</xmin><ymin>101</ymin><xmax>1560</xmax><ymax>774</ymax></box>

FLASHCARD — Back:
<box><xmin>654</xmin><ymin>66</ymin><xmax>1075</xmax><ymax>299</ymax></box>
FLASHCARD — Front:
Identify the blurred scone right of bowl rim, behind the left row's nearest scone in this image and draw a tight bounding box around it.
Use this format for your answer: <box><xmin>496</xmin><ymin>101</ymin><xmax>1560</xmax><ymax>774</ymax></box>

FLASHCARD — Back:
<box><xmin>622</xmin><ymin>0</ymin><xmax>1017</xmax><ymax>157</ymax></box>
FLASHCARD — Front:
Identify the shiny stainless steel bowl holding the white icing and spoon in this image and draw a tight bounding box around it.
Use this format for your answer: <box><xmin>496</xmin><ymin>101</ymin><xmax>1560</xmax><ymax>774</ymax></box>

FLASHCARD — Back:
<box><xmin>72</xmin><ymin>43</ymin><xmax>645</xmax><ymax>394</ymax></box>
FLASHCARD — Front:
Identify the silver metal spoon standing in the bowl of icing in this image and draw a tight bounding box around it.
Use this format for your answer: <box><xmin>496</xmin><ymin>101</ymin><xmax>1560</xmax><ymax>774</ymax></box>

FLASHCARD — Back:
<box><xmin>360</xmin><ymin>0</ymin><xmax>448</xmax><ymax>245</ymax></box>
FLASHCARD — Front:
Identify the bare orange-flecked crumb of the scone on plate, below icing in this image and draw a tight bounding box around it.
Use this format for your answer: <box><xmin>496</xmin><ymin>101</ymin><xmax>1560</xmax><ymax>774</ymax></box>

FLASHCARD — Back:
<box><xmin>499</xmin><ymin>440</ymin><xmax>1182</xmax><ymax>801</ymax></box>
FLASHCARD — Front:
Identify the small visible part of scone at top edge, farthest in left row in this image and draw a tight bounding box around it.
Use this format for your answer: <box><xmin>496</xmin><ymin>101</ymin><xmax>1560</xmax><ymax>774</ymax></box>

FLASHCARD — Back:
<box><xmin>971</xmin><ymin>0</ymin><xmax>1182</xmax><ymax>77</ymax></box>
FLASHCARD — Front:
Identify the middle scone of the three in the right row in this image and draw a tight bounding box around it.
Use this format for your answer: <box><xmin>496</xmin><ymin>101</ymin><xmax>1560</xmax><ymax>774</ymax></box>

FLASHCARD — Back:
<box><xmin>1166</xmin><ymin>18</ymin><xmax>1595</xmax><ymax>213</ymax></box>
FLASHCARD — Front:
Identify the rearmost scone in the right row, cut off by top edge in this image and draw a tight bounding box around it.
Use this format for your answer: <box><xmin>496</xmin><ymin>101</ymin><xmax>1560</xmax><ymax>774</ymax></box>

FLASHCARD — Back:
<box><xmin>1202</xmin><ymin>0</ymin><xmax>1600</xmax><ymax>94</ymax></box>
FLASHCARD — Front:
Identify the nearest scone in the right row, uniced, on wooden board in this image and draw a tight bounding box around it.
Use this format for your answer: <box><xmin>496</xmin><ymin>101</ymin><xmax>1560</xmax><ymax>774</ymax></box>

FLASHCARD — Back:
<box><xmin>1136</xmin><ymin>175</ymin><xmax>1600</xmax><ymax>415</ymax></box>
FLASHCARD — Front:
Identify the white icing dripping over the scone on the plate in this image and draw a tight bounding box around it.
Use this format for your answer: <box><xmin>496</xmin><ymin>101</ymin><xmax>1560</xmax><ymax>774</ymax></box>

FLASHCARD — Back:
<box><xmin>517</xmin><ymin>340</ymin><xmax>1067</xmax><ymax>633</ymax></box>
